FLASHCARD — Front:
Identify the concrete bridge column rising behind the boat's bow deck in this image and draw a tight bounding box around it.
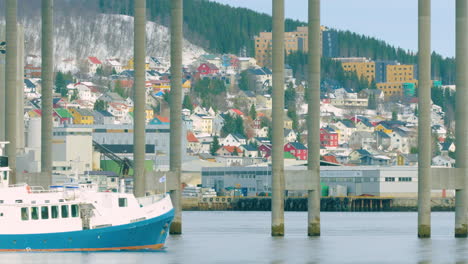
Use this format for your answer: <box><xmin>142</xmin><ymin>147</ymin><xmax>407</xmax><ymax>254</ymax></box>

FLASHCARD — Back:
<box><xmin>133</xmin><ymin>0</ymin><xmax>146</xmax><ymax>197</ymax></box>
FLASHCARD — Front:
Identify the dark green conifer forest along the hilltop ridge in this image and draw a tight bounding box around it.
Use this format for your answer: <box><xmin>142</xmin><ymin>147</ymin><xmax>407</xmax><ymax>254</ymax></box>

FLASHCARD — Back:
<box><xmin>97</xmin><ymin>0</ymin><xmax>455</xmax><ymax>84</ymax></box>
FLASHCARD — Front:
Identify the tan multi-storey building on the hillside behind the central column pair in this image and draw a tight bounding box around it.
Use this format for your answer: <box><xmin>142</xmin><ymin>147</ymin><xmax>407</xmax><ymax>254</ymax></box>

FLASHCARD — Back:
<box><xmin>255</xmin><ymin>26</ymin><xmax>327</xmax><ymax>67</ymax></box>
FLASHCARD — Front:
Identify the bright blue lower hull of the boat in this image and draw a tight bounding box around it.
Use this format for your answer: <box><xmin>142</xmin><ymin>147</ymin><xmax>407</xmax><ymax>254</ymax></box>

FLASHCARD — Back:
<box><xmin>0</xmin><ymin>209</ymin><xmax>174</xmax><ymax>252</ymax></box>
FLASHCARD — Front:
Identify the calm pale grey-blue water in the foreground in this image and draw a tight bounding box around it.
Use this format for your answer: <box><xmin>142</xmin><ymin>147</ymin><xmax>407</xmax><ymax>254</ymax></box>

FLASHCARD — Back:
<box><xmin>0</xmin><ymin>212</ymin><xmax>468</xmax><ymax>264</ymax></box>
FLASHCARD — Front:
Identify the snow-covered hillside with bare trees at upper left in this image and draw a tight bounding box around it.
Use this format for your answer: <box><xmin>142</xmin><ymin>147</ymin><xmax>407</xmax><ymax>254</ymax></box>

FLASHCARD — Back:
<box><xmin>3</xmin><ymin>14</ymin><xmax>205</xmax><ymax>71</ymax></box>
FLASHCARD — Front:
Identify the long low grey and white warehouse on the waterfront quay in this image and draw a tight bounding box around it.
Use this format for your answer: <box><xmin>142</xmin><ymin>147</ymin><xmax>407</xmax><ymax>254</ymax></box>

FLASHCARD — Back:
<box><xmin>202</xmin><ymin>166</ymin><xmax>453</xmax><ymax>197</ymax></box>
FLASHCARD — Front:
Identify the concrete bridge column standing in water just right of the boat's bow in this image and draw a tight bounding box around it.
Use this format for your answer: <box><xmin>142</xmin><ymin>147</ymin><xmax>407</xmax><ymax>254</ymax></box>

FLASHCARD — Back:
<box><xmin>170</xmin><ymin>0</ymin><xmax>185</xmax><ymax>235</ymax></box>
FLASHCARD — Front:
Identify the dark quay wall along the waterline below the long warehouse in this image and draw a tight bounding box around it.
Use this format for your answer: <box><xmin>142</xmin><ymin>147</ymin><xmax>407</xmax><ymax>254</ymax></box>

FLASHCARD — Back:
<box><xmin>182</xmin><ymin>197</ymin><xmax>455</xmax><ymax>212</ymax></box>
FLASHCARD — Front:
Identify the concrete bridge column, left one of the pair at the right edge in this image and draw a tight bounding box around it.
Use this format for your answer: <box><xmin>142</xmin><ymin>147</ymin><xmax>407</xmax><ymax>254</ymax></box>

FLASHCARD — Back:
<box><xmin>418</xmin><ymin>0</ymin><xmax>432</xmax><ymax>238</ymax></box>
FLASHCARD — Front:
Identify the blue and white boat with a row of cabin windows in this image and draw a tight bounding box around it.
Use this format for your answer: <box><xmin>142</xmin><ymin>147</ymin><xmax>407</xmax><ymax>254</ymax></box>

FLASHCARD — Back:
<box><xmin>0</xmin><ymin>142</ymin><xmax>174</xmax><ymax>252</ymax></box>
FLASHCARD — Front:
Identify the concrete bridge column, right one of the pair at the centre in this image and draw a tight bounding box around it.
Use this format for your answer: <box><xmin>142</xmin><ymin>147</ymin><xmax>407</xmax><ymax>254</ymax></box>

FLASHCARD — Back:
<box><xmin>307</xmin><ymin>0</ymin><xmax>321</xmax><ymax>236</ymax></box>
